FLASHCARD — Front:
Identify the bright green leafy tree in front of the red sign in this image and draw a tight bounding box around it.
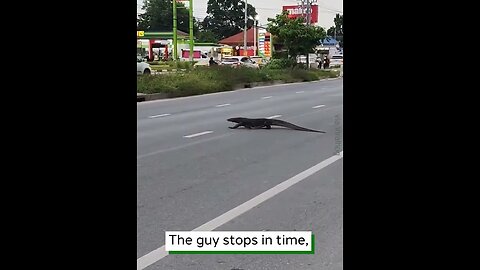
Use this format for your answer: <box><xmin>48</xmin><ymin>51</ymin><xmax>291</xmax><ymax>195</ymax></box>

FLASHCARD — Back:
<box><xmin>267</xmin><ymin>10</ymin><xmax>326</xmax><ymax>66</ymax></box>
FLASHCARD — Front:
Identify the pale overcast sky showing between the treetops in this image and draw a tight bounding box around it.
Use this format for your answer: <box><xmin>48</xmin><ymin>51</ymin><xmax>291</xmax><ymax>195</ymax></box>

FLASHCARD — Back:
<box><xmin>137</xmin><ymin>0</ymin><xmax>343</xmax><ymax>28</ymax></box>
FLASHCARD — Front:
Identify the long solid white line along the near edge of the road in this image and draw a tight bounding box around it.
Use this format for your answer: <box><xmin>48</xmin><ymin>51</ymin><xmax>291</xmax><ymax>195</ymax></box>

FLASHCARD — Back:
<box><xmin>137</xmin><ymin>151</ymin><xmax>343</xmax><ymax>270</ymax></box>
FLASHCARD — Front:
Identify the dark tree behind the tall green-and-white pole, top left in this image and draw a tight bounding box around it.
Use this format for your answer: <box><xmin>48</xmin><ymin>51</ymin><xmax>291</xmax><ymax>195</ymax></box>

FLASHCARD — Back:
<box><xmin>137</xmin><ymin>0</ymin><xmax>198</xmax><ymax>33</ymax></box>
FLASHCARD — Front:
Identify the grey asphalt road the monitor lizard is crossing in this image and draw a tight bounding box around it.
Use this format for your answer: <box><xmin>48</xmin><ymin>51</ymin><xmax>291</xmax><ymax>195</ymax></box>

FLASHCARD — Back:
<box><xmin>137</xmin><ymin>79</ymin><xmax>343</xmax><ymax>270</ymax></box>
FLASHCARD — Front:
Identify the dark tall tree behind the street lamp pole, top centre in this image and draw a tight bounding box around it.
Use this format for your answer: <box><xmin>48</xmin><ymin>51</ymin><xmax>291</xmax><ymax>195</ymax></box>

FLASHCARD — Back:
<box><xmin>202</xmin><ymin>0</ymin><xmax>257</xmax><ymax>39</ymax></box>
